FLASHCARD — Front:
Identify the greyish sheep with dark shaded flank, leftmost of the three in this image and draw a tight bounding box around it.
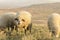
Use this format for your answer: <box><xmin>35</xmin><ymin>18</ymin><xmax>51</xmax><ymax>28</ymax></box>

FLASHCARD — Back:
<box><xmin>0</xmin><ymin>12</ymin><xmax>20</xmax><ymax>31</ymax></box>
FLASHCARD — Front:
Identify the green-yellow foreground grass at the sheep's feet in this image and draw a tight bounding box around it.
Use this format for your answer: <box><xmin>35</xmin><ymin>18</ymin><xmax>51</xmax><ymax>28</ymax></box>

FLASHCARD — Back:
<box><xmin>0</xmin><ymin>24</ymin><xmax>60</xmax><ymax>40</ymax></box>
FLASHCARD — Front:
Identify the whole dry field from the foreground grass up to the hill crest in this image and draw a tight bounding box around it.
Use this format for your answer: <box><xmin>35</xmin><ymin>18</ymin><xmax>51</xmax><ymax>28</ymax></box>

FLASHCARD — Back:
<box><xmin>0</xmin><ymin>3</ymin><xmax>60</xmax><ymax>40</ymax></box>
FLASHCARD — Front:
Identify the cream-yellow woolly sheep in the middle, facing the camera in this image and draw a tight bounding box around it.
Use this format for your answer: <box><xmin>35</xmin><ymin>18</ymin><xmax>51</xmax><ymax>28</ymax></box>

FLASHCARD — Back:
<box><xmin>18</xmin><ymin>11</ymin><xmax>32</xmax><ymax>34</ymax></box>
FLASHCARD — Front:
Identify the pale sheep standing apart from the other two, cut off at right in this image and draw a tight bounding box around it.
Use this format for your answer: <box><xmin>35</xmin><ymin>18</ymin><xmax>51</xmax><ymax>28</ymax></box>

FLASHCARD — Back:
<box><xmin>48</xmin><ymin>13</ymin><xmax>60</xmax><ymax>37</ymax></box>
